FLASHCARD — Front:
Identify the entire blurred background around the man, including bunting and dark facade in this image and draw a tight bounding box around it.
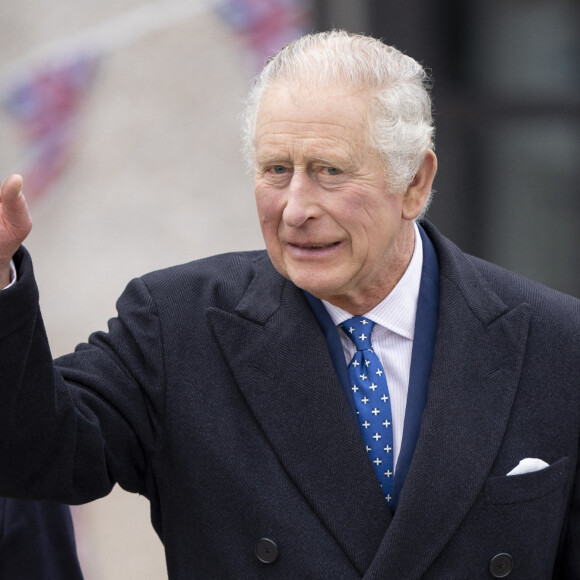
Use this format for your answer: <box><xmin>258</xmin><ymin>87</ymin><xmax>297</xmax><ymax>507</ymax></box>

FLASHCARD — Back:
<box><xmin>0</xmin><ymin>0</ymin><xmax>580</xmax><ymax>580</ymax></box>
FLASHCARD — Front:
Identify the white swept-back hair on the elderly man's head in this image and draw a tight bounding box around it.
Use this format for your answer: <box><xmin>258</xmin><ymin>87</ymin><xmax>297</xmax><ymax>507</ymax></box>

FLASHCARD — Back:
<box><xmin>242</xmin><ymin>31</ymin><xmax>434</xmax><ymax>199</ymax></box>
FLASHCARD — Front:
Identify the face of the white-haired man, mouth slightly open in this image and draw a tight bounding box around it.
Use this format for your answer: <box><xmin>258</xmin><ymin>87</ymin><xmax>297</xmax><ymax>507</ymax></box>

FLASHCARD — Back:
<box><xmin>255</xmin><ymin>86</ymin><xmax>414</xmax><ymax>314</ymax></box>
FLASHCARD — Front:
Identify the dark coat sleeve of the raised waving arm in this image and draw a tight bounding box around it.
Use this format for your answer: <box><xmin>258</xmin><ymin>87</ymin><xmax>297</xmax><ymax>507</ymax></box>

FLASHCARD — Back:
<box><xmin>0</xmin><ymin>249</ymin><xmax>163</xmax><ymax>504</ymax></box>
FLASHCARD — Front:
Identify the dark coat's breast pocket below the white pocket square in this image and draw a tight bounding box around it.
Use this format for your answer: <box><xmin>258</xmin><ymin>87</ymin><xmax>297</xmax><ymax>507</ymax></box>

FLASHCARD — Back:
<box><xmin>484</xmin><ymin>457</ymin><xmax>569</xmax><ymax>505</ymax></box>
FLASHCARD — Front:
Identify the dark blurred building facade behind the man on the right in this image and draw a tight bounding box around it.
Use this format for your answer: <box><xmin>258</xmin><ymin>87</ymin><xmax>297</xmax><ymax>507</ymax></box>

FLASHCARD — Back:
<box><xmin>315</xmin><ymin>0</ymin><xmax>580</xmax><ymax>296</ymax></box>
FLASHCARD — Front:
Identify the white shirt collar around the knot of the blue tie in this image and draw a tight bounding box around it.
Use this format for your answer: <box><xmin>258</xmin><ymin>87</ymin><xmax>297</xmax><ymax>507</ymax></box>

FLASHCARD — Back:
<box><xmin>322</xmin><ymin>223</ymin><xmax>423</xmax><ymax>340</ymax></box>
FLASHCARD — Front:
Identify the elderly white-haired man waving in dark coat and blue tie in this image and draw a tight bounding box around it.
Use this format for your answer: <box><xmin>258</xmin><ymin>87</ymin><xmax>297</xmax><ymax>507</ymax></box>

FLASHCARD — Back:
<box><xmin>0</xmin><ymin>32</ymin><xmax>580</xmax><ymax>580</ymax></box>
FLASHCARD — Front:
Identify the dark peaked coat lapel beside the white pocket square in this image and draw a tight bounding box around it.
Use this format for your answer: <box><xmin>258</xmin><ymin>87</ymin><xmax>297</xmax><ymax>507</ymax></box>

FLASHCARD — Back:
<box><xmin>365</xmin><ymin>228</ymin><xmax>529</xmax><ymax>580</ymax></box>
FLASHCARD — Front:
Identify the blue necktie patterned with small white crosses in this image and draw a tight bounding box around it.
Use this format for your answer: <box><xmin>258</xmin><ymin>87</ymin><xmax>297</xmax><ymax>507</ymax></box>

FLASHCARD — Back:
<box><xmin>340</xmin><ymin>316</ymin><xmax>394</xmax><ymax>504</ymax></box>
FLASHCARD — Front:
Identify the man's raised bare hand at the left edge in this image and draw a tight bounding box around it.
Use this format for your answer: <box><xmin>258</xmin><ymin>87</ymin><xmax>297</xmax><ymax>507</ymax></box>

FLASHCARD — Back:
<box><xmin>0</xmin><ymin>175</ymin><xmax>32</xmax><ymax>288</ymax></box>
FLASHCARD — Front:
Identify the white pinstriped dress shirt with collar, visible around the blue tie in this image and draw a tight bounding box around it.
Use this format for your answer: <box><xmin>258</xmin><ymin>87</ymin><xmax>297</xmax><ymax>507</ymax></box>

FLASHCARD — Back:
<box><xmin>322</xmin><ymin>224</ymin><xmax>423</xmax><ymax>470</ymax></box>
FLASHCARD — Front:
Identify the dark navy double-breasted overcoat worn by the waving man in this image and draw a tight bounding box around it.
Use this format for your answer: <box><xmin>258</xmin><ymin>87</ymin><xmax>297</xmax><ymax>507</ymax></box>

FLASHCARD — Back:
<box><xmin>0</xmin><ymin>224</ymin><xmax>580</xmax><ymax>580</ymax></box>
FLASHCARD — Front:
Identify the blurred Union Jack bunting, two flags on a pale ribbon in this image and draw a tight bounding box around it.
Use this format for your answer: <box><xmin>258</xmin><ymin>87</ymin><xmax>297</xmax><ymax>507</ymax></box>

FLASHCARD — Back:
<box><xmin>0</xmin><ymin>0</ymin><xmax>309</xmax><ymax>202</ymax></box>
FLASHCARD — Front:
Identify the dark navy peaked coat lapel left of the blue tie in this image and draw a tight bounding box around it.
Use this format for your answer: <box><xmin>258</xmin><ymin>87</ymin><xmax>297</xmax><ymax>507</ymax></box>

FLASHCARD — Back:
<box><xmin>208</xmin><ymin>255</ymin><xmax>392</xmax><ymax>574</ymax></box>
